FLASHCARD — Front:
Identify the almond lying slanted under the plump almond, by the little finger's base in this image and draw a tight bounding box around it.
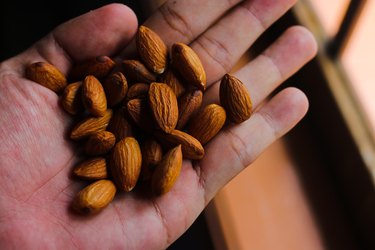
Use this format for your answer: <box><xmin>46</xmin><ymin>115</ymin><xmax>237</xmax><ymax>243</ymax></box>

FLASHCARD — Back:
<box><xmin>157</xmin><ymin>129</ymin><xmax>204</xmax><ymax>160</ymax></box>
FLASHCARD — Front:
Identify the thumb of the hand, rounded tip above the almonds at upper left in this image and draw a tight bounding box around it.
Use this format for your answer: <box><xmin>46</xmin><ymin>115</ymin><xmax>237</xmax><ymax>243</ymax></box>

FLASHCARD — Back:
<box><xmin>13</xmin><ymin>4</ymin><xmax>137</xmax><ymax>73</ymax></box>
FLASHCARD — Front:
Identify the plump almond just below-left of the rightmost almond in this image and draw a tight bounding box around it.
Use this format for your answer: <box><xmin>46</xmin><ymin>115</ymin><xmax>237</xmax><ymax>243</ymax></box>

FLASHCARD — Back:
<box><xmin>188</xmin><ymin>104</ymin><xmax>226</xmax><ymax>145</ymax></box>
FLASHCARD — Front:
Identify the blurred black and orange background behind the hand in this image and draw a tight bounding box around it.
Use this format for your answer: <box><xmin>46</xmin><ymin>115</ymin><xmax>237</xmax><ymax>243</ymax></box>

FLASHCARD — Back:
<box><xmin>0</xmin><ymin>0</ymin><xmax>375</xmax><ymax>250</ymax></box>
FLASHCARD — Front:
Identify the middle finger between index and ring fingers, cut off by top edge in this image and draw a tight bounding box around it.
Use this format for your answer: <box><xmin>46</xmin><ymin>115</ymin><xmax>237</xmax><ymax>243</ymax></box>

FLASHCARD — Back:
<box><xmin>191</xmin><ymin>0</ymin><xmax>296</xmax><ymax>84</ymax></box>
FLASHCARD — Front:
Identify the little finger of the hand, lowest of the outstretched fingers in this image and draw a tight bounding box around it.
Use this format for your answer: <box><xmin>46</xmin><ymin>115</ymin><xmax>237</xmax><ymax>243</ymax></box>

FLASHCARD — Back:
<box><xmin>197</xmin><ymin>88</ymin><xmax>308</xmax><ymax>202</ymax></box>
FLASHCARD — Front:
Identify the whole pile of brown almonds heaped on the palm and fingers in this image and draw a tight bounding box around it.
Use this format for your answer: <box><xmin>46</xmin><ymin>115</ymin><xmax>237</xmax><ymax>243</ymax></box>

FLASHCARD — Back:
<box><xmin>25</xmin><ymin>26</ymin><xmax>252</xmax><ymax>213</ymax></box>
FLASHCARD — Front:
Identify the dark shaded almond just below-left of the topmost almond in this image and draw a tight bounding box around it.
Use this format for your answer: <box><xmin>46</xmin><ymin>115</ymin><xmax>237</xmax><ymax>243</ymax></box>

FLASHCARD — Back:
<box><xmin>122</xmin><ymin>60</ymin><xmax>156</xmax><ymax>84</ymax></box>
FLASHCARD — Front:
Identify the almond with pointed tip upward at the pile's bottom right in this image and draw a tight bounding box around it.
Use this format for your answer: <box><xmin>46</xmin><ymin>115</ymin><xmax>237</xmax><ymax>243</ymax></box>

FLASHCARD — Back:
<box><xmin>151</xmin><ymin>145</ymin><xmax>182</xmax><ymax>195</ymax></box>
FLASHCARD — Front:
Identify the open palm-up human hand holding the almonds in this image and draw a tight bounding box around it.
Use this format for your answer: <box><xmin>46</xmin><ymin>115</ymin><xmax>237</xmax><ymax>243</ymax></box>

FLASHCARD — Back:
<box><xmin>0</xmin><ymin>0</ymin><xmax>316</xmax><ymax>249</ymax></box>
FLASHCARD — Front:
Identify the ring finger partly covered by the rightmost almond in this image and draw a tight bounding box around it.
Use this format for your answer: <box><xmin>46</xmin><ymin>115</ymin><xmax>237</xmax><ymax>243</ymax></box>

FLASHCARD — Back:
<box><xmin>204</xmin><ymin>26</ymin><xmax>317</xmax><ymax>108</ymax></box>
